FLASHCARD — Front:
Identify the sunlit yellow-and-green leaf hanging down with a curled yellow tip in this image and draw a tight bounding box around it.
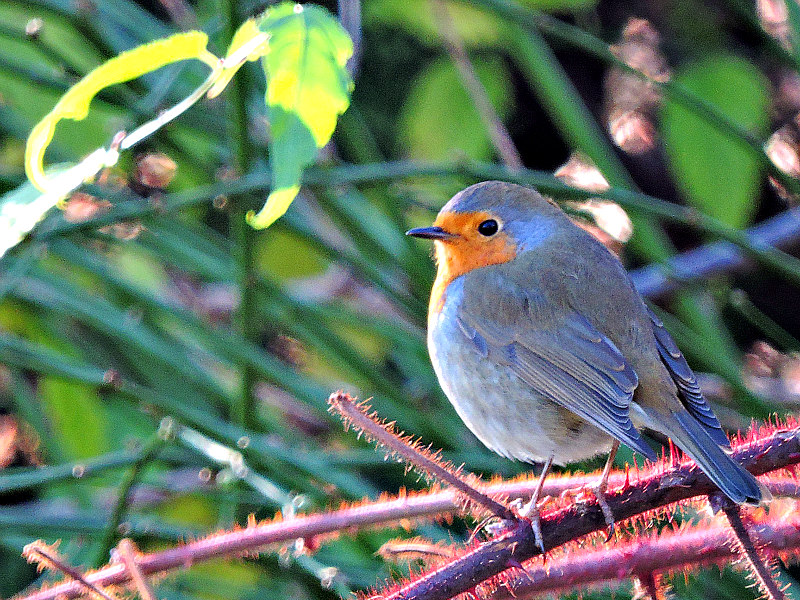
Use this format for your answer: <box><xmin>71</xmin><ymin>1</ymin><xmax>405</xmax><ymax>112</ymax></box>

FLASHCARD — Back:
<box><xmin>248</xmin><ymin>2</ymin><xmax>353</xmax><ymax>229</ymax></box>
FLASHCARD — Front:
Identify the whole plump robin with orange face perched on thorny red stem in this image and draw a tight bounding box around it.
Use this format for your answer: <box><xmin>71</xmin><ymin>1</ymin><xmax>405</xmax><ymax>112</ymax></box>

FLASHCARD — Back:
<box><xmin>408</xmin><ymin>181</ymin><xmax>769</xmax><ymax>549</ymax></box>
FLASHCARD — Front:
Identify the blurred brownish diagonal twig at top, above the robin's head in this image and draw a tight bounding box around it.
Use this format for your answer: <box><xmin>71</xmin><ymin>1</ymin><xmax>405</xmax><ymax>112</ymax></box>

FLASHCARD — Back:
<box><xmin>430</xmin><ymin>0</ymin><xmax>524</xmax><ymax>169</ymax></box>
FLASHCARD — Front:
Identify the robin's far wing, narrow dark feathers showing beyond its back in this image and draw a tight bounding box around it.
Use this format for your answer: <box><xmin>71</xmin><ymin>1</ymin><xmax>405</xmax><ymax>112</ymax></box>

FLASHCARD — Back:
<box><xmin>647</xmin><ymin>307</ymin><xmax>730</xmax><ymax>447</ymax></box>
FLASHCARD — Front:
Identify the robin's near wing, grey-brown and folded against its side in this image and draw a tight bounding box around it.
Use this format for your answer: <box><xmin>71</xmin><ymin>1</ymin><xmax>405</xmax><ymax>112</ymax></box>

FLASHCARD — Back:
<box><xmin>457</xmin><ymin>269</ymin><xmax>655</xmax><ymax>458</ymax></box>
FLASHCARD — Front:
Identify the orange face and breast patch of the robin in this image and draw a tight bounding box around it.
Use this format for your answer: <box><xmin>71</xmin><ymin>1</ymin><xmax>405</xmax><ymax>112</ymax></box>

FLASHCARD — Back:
<box><xmin>428</xmin><ymin>212</ymin><xmax>517</xmax><ymax>315</ymax></box>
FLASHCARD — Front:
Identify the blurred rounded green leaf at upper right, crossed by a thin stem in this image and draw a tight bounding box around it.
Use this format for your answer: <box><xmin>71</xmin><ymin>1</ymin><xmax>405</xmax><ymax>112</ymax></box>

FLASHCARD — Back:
<box><xmin>662</xmin><ymin>55</ymin><xmax>770</xmax><ymax>227</ymax></box>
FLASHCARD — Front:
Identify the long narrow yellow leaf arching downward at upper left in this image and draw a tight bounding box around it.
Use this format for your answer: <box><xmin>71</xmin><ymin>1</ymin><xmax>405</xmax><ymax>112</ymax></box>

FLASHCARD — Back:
<box><xmin>25</xmin><ymin>31</ymin><xmax>218</xmax><ymax>192</ymax></box>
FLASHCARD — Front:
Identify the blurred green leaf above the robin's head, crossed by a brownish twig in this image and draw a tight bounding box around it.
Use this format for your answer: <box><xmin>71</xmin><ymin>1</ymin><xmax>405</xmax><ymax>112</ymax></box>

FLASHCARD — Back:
<box><xmin>400</xmin><ymin>58</ymin><xmax>513</xmax><ymax>160</ymax></box>
